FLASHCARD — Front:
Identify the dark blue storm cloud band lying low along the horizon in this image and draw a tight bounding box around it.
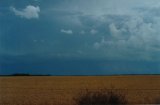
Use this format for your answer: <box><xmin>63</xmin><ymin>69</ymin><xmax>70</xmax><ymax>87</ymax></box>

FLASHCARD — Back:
<box><xmin>0</xmin><ymin>55</ymin><xmax>160</xmax><ymax>75</ymax></box>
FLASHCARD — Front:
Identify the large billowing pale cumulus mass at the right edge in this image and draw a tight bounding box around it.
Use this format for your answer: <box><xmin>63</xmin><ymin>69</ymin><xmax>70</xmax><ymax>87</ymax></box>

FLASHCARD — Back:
<box><xmin>90</xmin><ymin>7</ymin><xmax>160</xmax><ymax>60</ymax></box>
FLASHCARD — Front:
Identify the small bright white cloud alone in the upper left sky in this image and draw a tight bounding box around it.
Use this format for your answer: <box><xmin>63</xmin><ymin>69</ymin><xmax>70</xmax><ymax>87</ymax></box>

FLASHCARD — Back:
<box><xmin>10</xmin><ymin>5</ymin><xmax>40</xmax><ymax>19</ymax></box>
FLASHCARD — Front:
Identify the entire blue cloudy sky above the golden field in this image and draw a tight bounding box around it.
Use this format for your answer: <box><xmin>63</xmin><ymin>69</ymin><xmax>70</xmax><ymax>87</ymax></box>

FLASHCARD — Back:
<box><xmin>0</xmin><ymin>0</ymin><xmax>160</xmax><ymax>75</ymax></box>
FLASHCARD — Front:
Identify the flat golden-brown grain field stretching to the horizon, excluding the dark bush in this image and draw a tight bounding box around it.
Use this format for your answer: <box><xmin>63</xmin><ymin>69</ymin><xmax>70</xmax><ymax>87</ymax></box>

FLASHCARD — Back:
<box><xmin>0</xmin><ymin>76</ymin><xmax>160</xmax><ymax>105</ymax></box>
